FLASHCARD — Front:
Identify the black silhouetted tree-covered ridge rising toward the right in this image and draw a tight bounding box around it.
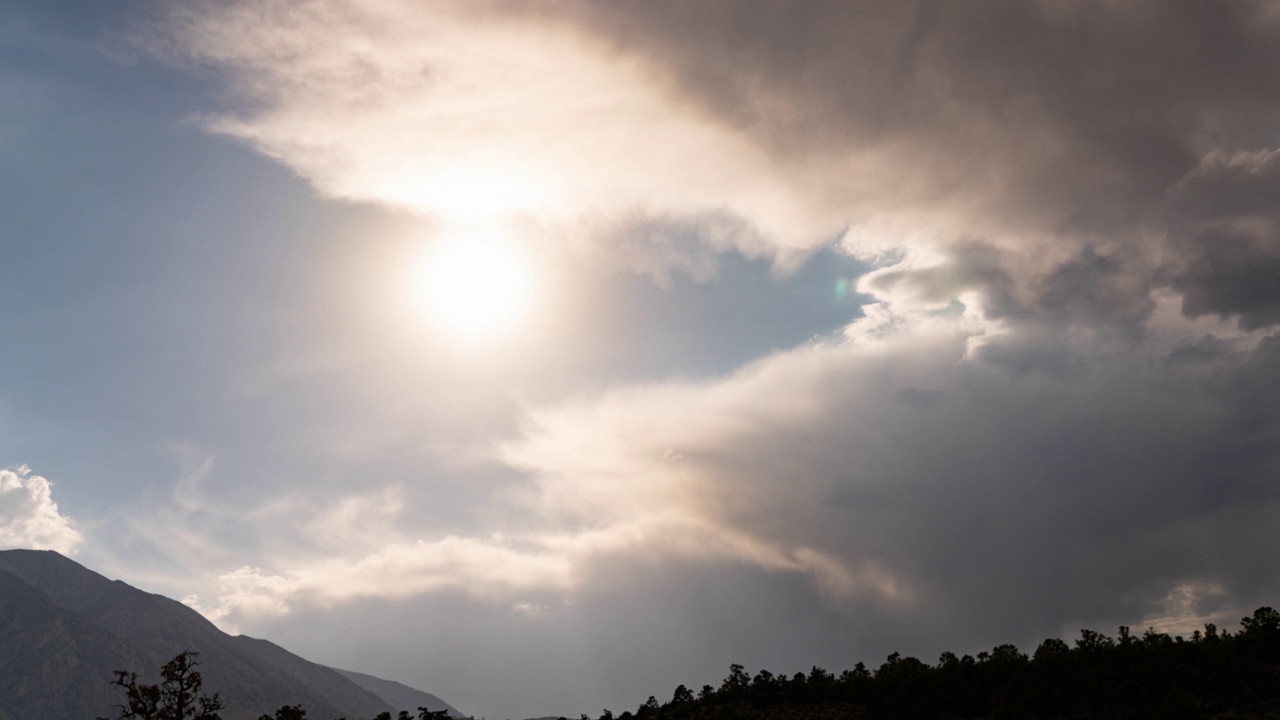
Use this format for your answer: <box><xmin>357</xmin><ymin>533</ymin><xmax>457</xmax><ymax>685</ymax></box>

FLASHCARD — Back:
<box><xmin>582</xmin><ymin>607</ymin><xmax>1280</xmax><ymax>720</ymax></box>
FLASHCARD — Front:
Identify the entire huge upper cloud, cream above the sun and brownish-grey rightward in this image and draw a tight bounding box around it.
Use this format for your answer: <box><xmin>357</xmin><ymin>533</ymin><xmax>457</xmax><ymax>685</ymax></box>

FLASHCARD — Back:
<box><xmin>136</xmin><ymin>0</ymin><xmax>1280</xmax><ymax>337</ymax></box>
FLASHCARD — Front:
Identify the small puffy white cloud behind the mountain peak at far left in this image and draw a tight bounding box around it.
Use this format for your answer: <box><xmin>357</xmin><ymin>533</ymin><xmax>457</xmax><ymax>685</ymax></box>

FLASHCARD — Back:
<box><xmin>0</xmin><ymin>465</ymin><xmax>83</xmax><ymax>555</ymax></box>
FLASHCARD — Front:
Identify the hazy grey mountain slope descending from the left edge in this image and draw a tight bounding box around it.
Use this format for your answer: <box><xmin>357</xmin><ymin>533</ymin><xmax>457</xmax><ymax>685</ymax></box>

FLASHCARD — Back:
<box><xmin>0</xmin><ymin>550</ymin><xmax>458</xmax><ymax>720</ymax></box>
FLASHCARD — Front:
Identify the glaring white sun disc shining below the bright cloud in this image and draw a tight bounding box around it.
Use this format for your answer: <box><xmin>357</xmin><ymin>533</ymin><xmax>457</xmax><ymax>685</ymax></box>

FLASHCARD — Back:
<box><xmin>415</xmin><ymin>237</ymin><xmax>534</xmax><ymax>343</ymax></box>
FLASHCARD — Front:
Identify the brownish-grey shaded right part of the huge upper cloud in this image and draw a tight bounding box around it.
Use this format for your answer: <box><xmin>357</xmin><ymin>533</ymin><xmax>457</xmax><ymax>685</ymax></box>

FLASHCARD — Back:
<box><xmin>517</xmin><ymin>0</ymin><xmax>1280</xmax><ymax>332</ymax></box>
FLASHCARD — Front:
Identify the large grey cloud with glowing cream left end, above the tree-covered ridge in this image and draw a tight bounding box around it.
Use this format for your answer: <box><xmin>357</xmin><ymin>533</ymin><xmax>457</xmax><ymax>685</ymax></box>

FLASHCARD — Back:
<box><xmin>504</xmin><ymin>311</ymin><xmax>1280</xmax><ymax>642</ymax></box>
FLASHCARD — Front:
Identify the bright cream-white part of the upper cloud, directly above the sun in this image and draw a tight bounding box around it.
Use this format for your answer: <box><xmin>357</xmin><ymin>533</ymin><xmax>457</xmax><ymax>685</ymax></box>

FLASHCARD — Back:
<box><xmin>141</xmin><ymin>1</ymin><xmax>846</xmax><ymax>264</ymax></box>
